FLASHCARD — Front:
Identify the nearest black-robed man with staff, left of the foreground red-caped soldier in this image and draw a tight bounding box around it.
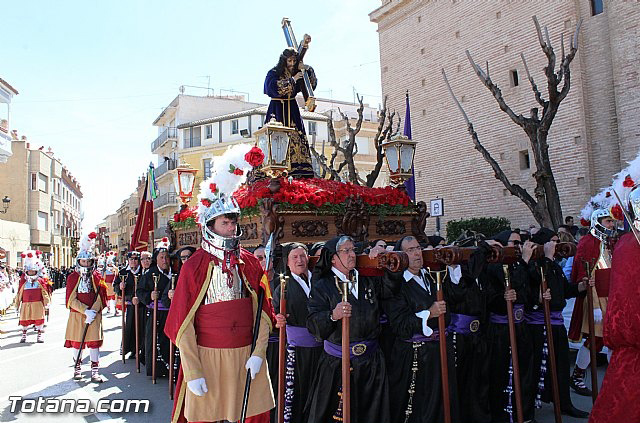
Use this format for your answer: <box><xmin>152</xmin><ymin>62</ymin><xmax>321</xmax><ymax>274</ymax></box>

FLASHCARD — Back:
<box><xmin>137</xmin><ymin>237</ymin><xmax>173</xmax><ymax>377</ymax></box>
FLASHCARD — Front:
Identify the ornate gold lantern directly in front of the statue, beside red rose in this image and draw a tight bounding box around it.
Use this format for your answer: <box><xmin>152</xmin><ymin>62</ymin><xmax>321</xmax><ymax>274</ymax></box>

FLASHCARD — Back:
<box><xmin>255</xmin><ymin>118</ymin><xmax>295</xmax><ymax>192</ymax></box>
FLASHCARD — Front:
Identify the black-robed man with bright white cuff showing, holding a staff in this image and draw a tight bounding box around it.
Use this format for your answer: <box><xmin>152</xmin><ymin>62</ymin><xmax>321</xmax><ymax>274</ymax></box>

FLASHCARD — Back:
<box><xmin>384</xmin><ymin>236</ymin><xmax>459</xmax><ymax>423</ymax></box>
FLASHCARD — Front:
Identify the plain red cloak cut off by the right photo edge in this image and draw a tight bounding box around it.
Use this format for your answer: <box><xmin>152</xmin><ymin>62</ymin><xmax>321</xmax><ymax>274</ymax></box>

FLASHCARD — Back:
<box><xmin>589</xmin><ymin>233</ymin><xmax>640</xmax><ymax>423</ymax></box>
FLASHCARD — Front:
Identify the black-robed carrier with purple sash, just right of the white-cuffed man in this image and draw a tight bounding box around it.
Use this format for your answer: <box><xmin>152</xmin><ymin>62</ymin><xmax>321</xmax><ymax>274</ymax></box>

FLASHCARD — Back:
<box><xmin>445</xmin><ymin>242</ymin><xmax>491</xmax><ymax>423</ymax></box>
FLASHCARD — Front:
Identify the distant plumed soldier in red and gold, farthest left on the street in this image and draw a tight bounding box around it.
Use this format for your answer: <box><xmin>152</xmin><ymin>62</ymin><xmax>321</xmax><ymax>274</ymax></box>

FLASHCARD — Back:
<box><xmin>14</xmin><ymin>250</ymin><xmax>51</xmax><ymax>343</ymax></box>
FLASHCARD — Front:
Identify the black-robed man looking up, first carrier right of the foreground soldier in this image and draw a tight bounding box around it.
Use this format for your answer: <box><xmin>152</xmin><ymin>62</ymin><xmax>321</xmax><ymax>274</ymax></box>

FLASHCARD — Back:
<box><xmin>273</xmin><ymin>242</ymin><xmax>322</xmax><ymax>422</ymax></box>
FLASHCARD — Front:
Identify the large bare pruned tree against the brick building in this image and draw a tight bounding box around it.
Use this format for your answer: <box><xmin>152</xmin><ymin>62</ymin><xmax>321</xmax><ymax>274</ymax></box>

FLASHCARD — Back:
<box><xmin>442</xmin><ymin>16</ymin><xmax>582</xmax><ymax>229</ymax></box>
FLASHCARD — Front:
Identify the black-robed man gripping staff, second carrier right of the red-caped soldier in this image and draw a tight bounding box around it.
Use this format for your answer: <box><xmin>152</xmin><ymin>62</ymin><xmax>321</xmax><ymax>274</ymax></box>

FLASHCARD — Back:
<box><xmin>303</xmin><ymin>236</ymin><xmax>403</xmax><ymax>423</ymax></box>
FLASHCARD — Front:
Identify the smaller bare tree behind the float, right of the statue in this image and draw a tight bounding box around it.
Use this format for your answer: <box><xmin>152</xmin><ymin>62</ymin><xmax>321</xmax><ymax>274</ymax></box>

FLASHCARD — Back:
<box><xmin>310</xmin><ymin>94</ymin><xmax>400</xmax><ymax>187</ymax></box>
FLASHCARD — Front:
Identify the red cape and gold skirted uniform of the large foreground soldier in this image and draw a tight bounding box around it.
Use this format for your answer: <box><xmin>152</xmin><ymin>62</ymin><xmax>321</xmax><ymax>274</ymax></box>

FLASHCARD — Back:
<box><xmin>165</xmin><ymin>248</ymin><xmax>274</xmax><ymax>422</ymax></box>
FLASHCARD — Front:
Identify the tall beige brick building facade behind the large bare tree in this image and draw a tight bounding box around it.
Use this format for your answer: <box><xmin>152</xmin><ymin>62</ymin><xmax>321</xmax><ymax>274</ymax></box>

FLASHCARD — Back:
<box><xmin>369</xmin><ymin>0</ymin><xmax>640</xmax><ymax>231</ymax></box>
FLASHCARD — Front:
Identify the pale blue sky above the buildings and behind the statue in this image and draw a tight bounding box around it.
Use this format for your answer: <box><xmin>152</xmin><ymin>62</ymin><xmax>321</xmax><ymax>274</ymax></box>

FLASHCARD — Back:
<box><xmin>0</xmin><ymin>0</ymin><xmax>381</xmax><ymax>231</ymax></box>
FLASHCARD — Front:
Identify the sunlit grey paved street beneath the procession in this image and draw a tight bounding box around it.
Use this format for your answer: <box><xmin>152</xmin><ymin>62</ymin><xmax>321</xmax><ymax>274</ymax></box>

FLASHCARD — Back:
<box><xmin>0</xmin><ymin>290</ymin><xmax>603</xmax><ymax>423</ymax></box>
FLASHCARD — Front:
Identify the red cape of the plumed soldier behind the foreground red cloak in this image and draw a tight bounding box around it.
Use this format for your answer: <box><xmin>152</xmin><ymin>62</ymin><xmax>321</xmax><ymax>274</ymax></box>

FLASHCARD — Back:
<box><xmin>568</xmin><ymin>234</ymin><xmax>600</xmax><ymax>341</ymax></box>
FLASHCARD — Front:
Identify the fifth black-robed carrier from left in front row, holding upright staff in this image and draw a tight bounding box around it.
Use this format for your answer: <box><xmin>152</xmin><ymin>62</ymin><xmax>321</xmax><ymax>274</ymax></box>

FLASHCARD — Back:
<box><xmin>479</xmin><ymin>230</ymin><xmax>535</xmax><ymax>422</ymax></box>
